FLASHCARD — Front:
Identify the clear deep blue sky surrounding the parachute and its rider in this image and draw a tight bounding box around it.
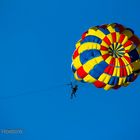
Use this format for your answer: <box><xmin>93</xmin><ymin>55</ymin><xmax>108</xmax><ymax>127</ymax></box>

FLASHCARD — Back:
<box><xmin>0</xmin><ymin>0</ymin><xmax>140</xmax><ymax>140</ymax></box>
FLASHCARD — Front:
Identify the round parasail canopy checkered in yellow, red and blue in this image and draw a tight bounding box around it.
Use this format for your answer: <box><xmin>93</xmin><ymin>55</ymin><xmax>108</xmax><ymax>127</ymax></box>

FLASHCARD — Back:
<box><xmin>72</xmin><ymin>23</ymin><xmax>140</xmax><ymax>90</ymax></box>
